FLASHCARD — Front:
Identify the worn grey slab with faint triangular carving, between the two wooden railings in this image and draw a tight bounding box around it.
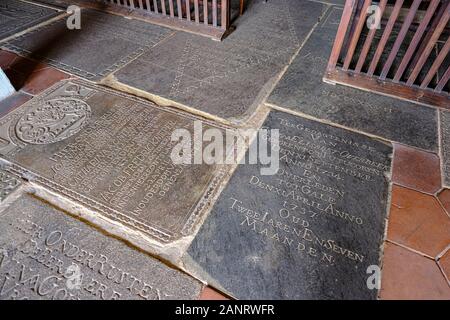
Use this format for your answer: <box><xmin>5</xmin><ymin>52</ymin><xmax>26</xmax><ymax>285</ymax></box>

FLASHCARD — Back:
<box><xmin>115</xmin><ymin>0</ymin><xmax>326</xmax><ymax>122</ymax></box>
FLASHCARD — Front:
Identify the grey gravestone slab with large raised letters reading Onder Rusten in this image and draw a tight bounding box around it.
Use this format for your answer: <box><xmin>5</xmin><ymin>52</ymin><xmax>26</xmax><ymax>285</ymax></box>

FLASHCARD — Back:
<box><xmin>0</xmin><ymin>194</ymin><xmax>202</xmax><ymax>300</ymax></box>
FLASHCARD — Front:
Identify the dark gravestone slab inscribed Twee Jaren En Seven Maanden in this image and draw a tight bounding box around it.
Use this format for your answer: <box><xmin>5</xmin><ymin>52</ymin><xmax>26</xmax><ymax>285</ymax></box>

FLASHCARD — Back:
<box><xmin>183</xmin><ymin>111</ymin><xmax>392</xmax><ymax>299</ymax></box>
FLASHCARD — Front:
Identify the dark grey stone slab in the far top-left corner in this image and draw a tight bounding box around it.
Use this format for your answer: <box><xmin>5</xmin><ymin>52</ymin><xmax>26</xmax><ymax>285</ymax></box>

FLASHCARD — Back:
<box><xmin>0</xmin><ymin>0</ymin><xmax>58</xmax><ymax>40</ymax></box>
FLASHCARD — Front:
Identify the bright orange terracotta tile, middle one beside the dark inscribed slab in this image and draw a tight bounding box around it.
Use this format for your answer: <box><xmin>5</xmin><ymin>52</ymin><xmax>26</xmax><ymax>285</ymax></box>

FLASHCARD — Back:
<box><xmin>388</xmin><ymin>185</ymin><xmax>450</xmax><ymax>257</ymax></box>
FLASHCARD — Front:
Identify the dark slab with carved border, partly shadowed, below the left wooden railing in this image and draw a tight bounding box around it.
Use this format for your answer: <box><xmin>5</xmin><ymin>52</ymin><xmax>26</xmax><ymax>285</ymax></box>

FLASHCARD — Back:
<box><xmin>4</xmin><ymin>9</ymin><xmax>171</xmax><ymax>80</ymax></box>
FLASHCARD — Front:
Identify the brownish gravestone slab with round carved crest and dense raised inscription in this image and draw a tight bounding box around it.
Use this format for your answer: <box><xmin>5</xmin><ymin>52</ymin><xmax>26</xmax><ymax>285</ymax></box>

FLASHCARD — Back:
<box><xmin>0</xmin><ymin>81</ymin><xmax>225</xmax><ymax>244</ymax></box>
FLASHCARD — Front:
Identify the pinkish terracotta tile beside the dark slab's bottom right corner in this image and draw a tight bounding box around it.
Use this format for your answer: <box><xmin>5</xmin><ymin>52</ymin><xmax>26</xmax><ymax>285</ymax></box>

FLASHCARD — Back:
<box><xmin>380</xmin><ymin>243</ymin><xmax>450</xmax><ymax>300</ymax></box>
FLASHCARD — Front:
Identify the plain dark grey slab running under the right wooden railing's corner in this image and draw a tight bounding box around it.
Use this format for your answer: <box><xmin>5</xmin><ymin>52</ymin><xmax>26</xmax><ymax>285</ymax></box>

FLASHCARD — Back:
<box><xmin>268</xmin><ymin>7</ymin><xmax>438</xmax><ymax>151</ymax></box>
